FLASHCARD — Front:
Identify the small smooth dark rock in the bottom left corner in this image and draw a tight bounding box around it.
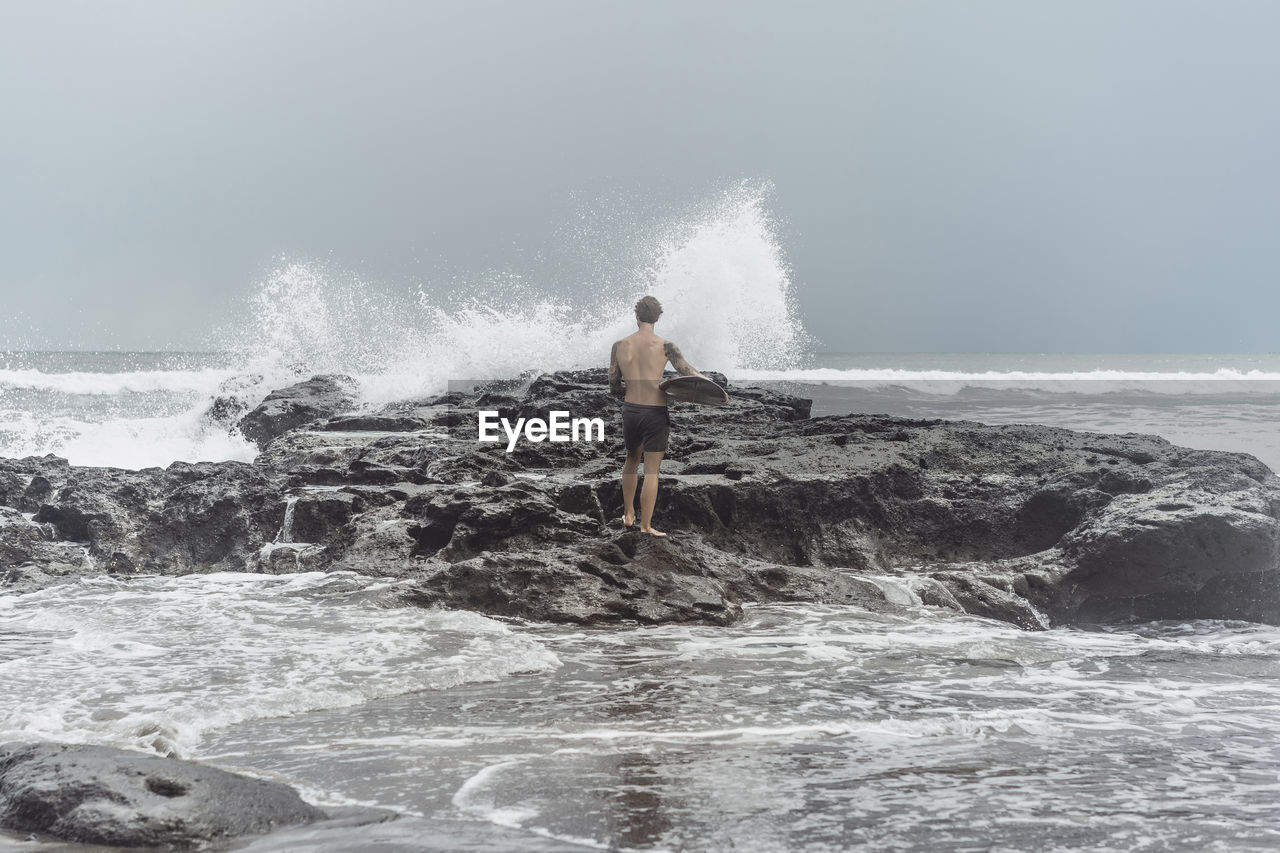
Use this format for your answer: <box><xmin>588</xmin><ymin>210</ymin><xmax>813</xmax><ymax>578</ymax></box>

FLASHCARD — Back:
<box><xmin>0</xmin><ymin>743</ymin><xmax>325</xmax><ymax>848</ymax></box>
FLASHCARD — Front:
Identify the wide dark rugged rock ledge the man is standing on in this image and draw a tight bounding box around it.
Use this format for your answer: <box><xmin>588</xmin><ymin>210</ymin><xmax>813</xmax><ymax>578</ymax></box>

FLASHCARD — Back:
<box><xmin>0</xmin><ymin>371</ymin><xmax>1280</xmax><ymax>629</ymax></box>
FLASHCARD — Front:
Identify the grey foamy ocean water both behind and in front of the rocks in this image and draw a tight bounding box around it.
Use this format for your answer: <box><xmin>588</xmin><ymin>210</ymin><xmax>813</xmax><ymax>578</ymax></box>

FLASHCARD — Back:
<box><xmin>0</xmin><ymin>343</ymin><xmax>1280</xmax><ymax>850</ymax></box>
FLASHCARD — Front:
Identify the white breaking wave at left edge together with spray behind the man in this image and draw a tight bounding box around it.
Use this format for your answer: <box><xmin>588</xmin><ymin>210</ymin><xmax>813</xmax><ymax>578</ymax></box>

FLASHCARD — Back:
<box><xmin>0</xmin><ymin>183</ymin><xmax>806</xmax><ymax>467</ymax></box>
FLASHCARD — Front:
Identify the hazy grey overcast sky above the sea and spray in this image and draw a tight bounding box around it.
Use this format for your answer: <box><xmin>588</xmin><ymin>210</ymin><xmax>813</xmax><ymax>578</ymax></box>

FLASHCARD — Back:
<box><xmin>0</xmin><ymin>0</ymin><xmax>1280</xmax><ymax>352</ymax></box>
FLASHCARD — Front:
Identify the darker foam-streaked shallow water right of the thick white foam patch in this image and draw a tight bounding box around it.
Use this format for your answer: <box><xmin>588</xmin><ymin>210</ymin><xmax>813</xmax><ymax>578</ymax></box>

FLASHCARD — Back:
<box><xmin>183</xmin><ymin>596</ymin><xmax>1280</xmax><ymax>850</ymax></box>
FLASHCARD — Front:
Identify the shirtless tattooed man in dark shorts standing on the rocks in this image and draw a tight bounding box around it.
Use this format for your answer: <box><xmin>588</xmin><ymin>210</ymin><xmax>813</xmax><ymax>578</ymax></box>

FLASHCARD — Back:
<box><xmin>609</xmin><ymin>296</ymin><xmax>701</xmax><ymax>537</ymax></box>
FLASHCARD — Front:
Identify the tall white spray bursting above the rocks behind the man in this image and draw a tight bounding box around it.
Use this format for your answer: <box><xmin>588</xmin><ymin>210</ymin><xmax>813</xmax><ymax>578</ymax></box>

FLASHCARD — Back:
<box><xmin>215</xmin><ymin>184</ymin><xmax>809</xmax><ymax>403</ymax></box>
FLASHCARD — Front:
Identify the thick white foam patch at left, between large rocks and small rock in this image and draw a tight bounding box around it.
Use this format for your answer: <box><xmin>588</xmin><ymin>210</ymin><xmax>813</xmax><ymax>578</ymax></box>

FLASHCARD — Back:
<box><xmin>0</xmin><ymin>573</ymin><xmax>559</xmax><ymax>754</ymax></box>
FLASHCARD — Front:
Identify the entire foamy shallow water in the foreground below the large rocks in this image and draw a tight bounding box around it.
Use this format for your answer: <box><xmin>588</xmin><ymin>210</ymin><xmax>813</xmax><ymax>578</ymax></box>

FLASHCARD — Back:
<box><xmin>0</xmin><ymin>575</ymin><xmax>1280</xmax><ymax>850</ymax></box>
